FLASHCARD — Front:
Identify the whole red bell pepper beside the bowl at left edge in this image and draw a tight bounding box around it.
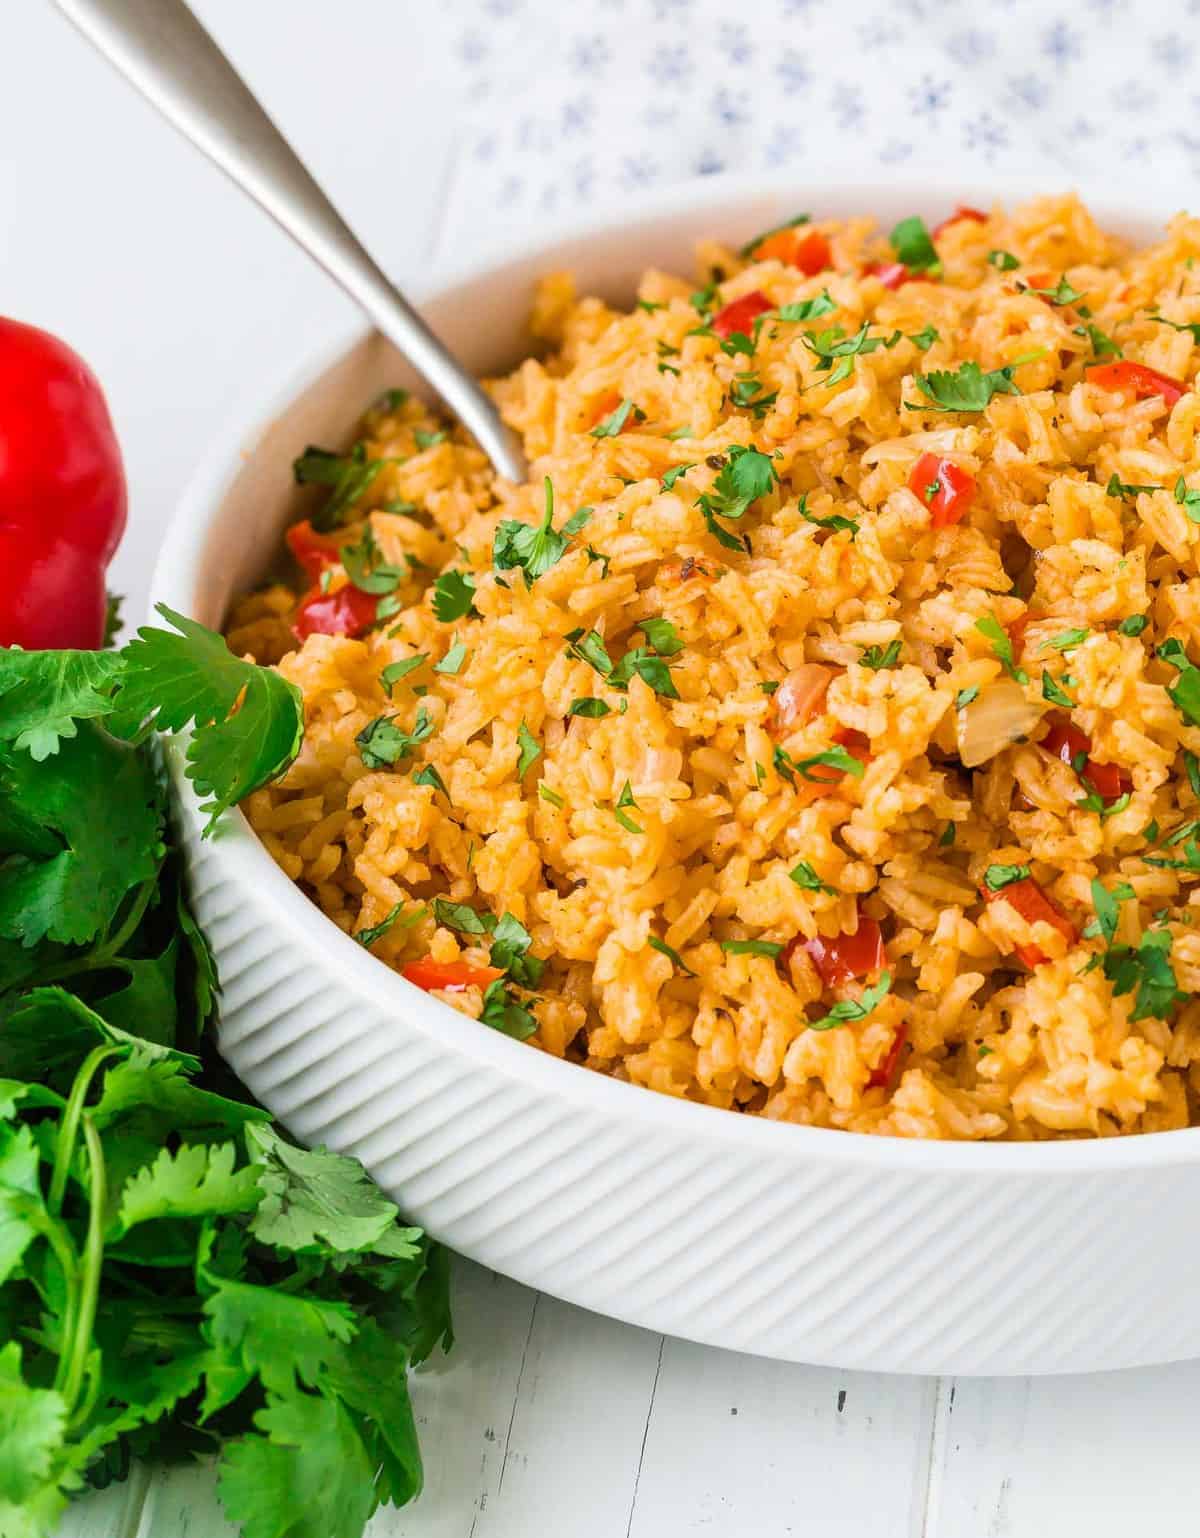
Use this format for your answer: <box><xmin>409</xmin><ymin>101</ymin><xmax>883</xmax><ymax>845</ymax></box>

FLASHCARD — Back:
<box><xmin>0</xmin><ymin>317</ymin><xmax>128</xmax><ymax>651</ymax></box>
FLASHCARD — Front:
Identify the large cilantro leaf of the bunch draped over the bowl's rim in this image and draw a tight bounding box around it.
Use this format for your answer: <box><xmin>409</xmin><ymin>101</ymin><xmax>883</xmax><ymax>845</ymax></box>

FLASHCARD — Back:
<box><xmin>117</xmin><ymin>603</ymin><xmax>305</xmax><ymax>834</ymax></box>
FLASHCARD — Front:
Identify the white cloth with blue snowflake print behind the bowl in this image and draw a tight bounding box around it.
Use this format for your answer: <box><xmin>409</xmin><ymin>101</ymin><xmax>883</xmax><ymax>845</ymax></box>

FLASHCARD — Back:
<box><xmin>443</xmin><ymin>0</ymin><xmax>1200</xmax><ymax>243</ymax></box>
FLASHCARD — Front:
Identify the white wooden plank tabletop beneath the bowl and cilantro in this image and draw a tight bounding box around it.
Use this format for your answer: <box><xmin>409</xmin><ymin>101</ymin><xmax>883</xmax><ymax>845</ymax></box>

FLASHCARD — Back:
<box><xmin>9</xmin><ymin>0</ymin><xmax>1200</xmax><ymax>1538</ymax></box>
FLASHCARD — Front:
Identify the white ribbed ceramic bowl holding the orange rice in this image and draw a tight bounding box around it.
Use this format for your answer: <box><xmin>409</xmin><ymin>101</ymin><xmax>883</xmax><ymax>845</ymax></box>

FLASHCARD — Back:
<box><xmin>154</xmin><ymin>177</ymin><xmax>1200</xmax><ymax>1373</ymax></box>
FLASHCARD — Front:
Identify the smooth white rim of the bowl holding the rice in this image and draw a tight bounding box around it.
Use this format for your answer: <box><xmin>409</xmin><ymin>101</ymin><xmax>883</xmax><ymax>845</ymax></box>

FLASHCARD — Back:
<box><xmin>149</xmin><ymin>168</ymin><xmax>1200</xmax><ymax>1180</ymax></box>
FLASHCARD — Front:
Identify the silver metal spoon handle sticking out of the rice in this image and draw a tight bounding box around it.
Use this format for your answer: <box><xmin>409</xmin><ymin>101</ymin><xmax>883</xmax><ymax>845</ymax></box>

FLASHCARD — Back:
<box><xmin>55</xmin><ymin>0</ymin><xmax>526</xmax><ymax>481</ymax></box>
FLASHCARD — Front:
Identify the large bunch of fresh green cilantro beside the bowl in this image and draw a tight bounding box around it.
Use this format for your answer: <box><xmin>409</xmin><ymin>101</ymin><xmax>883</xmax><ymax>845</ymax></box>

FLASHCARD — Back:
<box><xmin>0</xmin><ymin>611</ymin><xmax>451</xmax><ymax>1538</ymax></box>
